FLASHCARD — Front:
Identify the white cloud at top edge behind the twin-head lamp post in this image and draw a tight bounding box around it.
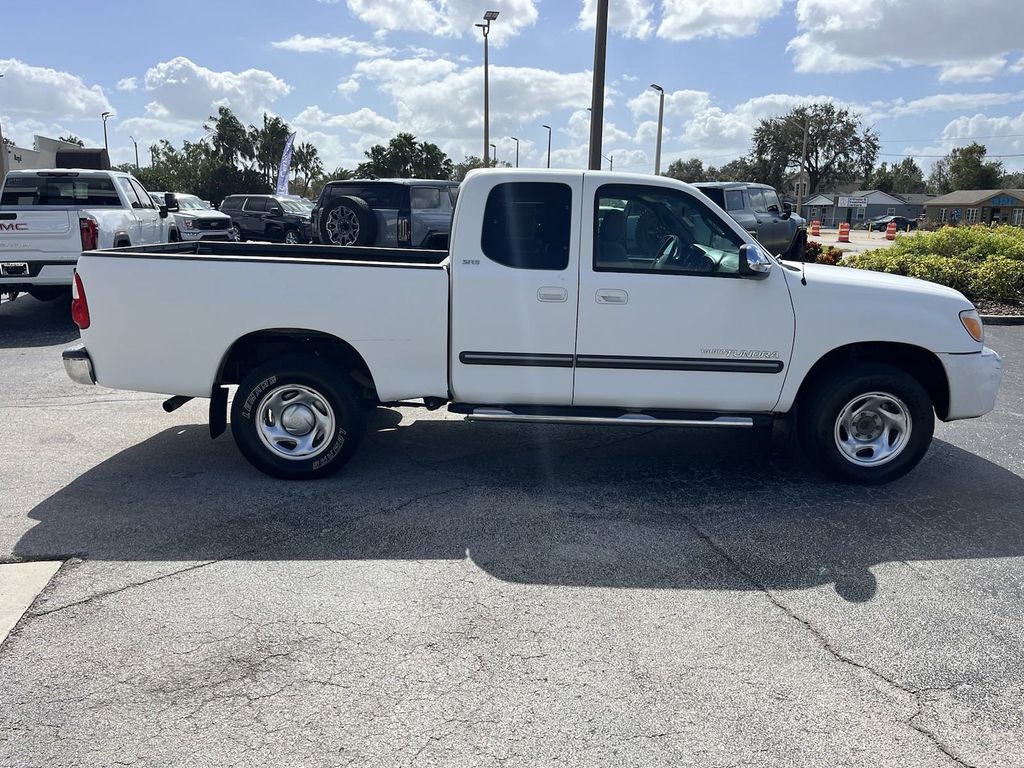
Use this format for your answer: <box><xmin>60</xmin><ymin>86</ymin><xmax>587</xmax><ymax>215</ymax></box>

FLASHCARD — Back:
<box><xmin>346</xmin><ymin>0</ymin><xmax>537</xmax><ymax>46</ymax></box>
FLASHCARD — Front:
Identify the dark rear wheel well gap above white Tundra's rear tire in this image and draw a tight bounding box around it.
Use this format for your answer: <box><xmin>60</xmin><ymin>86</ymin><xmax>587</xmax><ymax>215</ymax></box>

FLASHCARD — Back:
<box><xmin>217</xmin><ymin>328</ymin><xmax>378</xmax><ymax>400</ymax></box>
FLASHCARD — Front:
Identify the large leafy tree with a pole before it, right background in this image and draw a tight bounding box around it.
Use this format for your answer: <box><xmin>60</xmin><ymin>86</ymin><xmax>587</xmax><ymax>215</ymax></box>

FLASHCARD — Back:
<box><xmin>751</xmin><ymin>101</ymin><xmax>879</xmax><ymax>194</ymax></box>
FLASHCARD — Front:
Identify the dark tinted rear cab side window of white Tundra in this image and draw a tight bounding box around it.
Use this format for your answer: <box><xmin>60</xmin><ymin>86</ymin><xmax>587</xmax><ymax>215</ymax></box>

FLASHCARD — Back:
<box><xmin>480</xmin><ymin>181</ymin><xmax>572</xmax><ymax>270</ymax></box>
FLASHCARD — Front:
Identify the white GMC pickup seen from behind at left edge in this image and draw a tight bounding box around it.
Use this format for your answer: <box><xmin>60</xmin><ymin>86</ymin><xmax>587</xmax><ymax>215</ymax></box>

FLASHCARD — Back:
<box><xmin>0</xmin><ymin>169</ymin><xmax>167</xmax><ymax>300</ymax></box>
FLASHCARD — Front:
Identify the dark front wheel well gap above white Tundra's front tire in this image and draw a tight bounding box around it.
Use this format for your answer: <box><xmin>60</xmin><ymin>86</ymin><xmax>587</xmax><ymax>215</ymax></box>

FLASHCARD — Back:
<box><xmin>797</xmin><ymin>341</ymin><xmax>949</xmax><ymax>419</ymax></box>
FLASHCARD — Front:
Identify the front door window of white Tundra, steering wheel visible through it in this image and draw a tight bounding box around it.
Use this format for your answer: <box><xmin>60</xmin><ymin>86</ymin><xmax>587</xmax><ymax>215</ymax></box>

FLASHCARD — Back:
<box><xmin>594</xmin><ymin>184</ymin><xmax>743</xmax><ymax>274</ymax></box>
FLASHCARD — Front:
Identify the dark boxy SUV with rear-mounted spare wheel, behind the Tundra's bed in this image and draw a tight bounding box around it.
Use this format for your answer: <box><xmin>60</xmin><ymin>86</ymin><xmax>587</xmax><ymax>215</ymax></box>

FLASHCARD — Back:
<box><xmin>312</xmin><ymin>179</ymin><xmax>459</xmax><ymax>249</ymax></box>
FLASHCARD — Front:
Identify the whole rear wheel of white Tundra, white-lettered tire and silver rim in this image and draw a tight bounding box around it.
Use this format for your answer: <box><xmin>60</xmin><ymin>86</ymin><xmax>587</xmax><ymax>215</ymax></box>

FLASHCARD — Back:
<box><xmin>231</xmin><ymin>357</ymin><xmax>366</xmax><ymax>480</ymax></box>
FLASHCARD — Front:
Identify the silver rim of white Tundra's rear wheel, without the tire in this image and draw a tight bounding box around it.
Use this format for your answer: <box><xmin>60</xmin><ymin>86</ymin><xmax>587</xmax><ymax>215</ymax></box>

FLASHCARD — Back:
<box><xmin>256</xmin><ymin>384</ymin><xmax>335</xmax><ymax>461</ymax></box>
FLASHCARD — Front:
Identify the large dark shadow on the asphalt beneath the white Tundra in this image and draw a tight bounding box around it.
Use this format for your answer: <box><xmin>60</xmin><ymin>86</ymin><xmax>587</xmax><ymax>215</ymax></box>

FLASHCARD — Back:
<box><xmin>14</xmin><ymin>409</ymin><xmax>1024</xmax><ymax>602</ymax></box>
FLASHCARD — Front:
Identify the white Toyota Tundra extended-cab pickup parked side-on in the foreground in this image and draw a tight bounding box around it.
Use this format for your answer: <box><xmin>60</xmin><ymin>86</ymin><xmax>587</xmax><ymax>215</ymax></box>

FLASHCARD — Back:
<box><xmin>63</xmin><ymin>170</ymin><xmax>1002</xmax><ymax>483</ymax></box>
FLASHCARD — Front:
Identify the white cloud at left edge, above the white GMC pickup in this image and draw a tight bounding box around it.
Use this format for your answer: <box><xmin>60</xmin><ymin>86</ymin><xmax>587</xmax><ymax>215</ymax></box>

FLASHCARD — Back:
<box><xmin>0</xmin><ymin>58</ymin><xmax>114</xmax><ymax>120</ymax></box>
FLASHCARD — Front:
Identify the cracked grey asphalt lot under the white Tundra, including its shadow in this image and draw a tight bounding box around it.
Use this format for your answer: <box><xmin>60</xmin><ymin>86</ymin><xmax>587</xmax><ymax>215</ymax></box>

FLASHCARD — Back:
<box><xmin>0</xmin><ymin>298</ymin><xmax>1024</xmax><ymax>768</ymax></box>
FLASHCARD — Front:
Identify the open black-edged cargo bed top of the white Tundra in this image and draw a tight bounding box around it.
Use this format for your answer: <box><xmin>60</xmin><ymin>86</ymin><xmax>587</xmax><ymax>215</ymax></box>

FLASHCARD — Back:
<box><xmin>116</xmin><ymin>241</ymin><xmax>449</xmax><ymax>264</ymax></box>
